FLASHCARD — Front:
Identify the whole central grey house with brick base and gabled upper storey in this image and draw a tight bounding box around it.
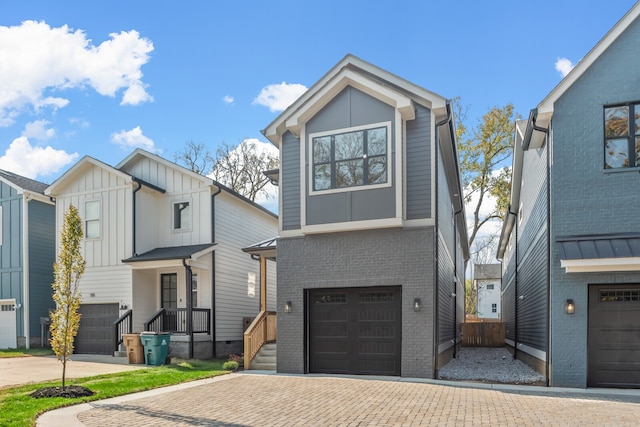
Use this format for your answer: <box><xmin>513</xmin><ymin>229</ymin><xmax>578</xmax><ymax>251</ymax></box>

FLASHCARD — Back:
<box><xmin>263</xmin><ymin>55</ymin><xmax>469</xmax><ymax>378</ymax></box>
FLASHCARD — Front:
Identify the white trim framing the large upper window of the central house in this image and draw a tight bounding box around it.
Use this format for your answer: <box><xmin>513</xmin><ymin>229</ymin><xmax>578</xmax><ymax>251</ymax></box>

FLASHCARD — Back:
<box><xmin>307</xmin><ymin>121</ymin><xmax>396</xmax><ymax>196</ymax></box>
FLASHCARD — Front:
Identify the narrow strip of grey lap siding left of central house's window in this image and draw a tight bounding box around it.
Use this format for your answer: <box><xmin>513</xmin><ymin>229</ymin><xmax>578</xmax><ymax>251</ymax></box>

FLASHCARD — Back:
<box><xmin>280</xmin><ymin>131</ymin><xmax>300</xmax><ymax>230</ymax></box>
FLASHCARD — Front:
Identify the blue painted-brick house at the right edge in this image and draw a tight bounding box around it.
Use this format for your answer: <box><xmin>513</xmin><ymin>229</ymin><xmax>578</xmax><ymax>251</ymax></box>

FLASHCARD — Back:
<box><xmin>498</xmin><ymin>4</ymin><xmax>640</xmax><ymax>388</ymax></box>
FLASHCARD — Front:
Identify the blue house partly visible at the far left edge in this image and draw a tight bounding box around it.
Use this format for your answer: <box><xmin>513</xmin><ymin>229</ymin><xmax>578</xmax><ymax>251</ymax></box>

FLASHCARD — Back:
<box><xmin>0</xmin><ymin>170</ymin><xmax>56</xmax><ymax>348</ymax></box>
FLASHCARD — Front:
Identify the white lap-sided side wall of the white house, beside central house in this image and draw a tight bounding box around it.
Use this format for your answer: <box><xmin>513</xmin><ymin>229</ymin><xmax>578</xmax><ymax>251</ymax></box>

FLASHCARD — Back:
<box><xmin>214</xmin><ymin>191</ymin><xmax>278</xmax><ymax>341</ymax></box>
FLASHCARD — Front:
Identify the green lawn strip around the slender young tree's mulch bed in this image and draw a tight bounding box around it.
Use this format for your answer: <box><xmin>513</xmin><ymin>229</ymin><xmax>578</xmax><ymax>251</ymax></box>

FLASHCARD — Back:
<box><xmin>0</xmin><ymin>358</ymin><xmax>228</xmax><ymax>427</ymax></box>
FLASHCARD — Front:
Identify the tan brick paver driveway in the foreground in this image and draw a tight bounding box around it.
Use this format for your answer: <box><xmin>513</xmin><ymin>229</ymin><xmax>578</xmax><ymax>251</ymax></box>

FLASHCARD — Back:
<box><xmin>78</xmin><ymin>375</ymin><xmax>640</xmax><ymax>427</ymax></box>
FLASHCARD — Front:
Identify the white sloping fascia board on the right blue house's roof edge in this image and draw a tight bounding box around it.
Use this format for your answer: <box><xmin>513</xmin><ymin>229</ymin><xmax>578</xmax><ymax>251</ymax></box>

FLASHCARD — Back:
<box><xmin>538</xmin><ymin>2</ymin><xmax>640</xmax><ymax>113</ymax></box>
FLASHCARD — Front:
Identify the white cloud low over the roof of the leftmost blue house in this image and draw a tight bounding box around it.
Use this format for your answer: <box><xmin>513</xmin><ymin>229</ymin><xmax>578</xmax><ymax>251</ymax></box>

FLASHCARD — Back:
<box><xmin>0</xmin><ymin>136</ymin><xmax>78</xmax><ymax>179</ymax></box>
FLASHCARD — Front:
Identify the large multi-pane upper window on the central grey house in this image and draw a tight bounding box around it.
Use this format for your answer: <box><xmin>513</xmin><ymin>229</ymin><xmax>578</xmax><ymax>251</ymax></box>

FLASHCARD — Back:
<box><xmin>310</xmin><ymin>124</ymin><xmax>389</xmax><ymax>191</ymax></box>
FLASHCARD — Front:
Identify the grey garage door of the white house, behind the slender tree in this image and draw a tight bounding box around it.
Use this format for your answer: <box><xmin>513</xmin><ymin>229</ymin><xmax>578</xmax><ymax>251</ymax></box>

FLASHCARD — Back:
<box><xmin>75</xmin><ymin>304</ymin><xmax>118</xmax><ymax>355</ymax></box>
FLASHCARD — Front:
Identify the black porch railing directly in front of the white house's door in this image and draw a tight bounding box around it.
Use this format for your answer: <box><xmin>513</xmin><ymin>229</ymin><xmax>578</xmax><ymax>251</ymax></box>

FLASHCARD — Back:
<box><xmin>144</xmin><ymin>308</ymin><xmax>211</xmax><ymax>335</ymax></box>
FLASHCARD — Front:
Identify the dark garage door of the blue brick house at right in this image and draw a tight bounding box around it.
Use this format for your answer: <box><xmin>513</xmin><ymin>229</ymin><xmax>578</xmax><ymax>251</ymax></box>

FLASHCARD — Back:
<box><xmin>587</xmin><ymin>285</ymin><xmax>640</xmax><ymax>388</ymax></box>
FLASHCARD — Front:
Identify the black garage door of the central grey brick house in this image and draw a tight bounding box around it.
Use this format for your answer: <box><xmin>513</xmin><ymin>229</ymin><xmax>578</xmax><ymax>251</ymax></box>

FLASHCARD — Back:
<box><xmin>307</xmin><ymin>287</ymin><xmax>402</xmax><ymax>375</ymax></box>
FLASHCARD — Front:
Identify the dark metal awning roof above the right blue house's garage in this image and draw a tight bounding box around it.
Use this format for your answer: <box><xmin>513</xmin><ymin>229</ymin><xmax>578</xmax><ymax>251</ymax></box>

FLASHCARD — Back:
<box><xmin>556</xmin><ymin>233</ymin><xmax>640</xmax><ymax>260</ymax></box>
